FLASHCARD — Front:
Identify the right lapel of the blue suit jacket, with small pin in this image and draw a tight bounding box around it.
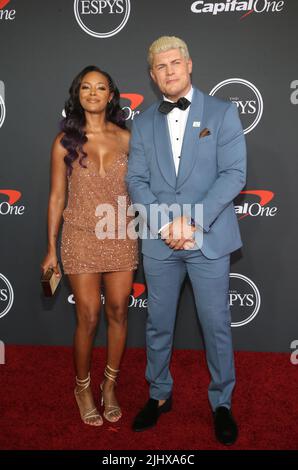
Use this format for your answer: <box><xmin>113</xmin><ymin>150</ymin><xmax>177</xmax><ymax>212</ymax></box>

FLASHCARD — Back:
<box><xmin>176</xmin><ymin>88</ymin><xmax>204</xmax><ymax>188</ymax></box>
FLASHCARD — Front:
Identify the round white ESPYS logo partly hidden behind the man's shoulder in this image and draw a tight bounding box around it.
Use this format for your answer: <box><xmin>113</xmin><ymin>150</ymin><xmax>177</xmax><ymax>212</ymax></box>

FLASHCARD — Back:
<box><xmin>209</xmin><ymin>78</ymin><xmax>264</xmax><ymax>134</ymax></box>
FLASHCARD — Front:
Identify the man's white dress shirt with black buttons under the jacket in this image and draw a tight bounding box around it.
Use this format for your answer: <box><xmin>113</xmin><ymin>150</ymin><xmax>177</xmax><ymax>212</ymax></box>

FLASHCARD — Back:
<box><xmin>164</xmin><ymin>87</ymin><xmax>193</xmax><ymax>176</ymax></box>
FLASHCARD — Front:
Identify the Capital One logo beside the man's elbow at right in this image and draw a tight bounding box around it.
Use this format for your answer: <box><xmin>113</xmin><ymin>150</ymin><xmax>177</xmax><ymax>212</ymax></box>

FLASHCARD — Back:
<box><xmin>235</xmin><ymin>189</ymin><xmax>277</xmax><ymax>220</ymax></box>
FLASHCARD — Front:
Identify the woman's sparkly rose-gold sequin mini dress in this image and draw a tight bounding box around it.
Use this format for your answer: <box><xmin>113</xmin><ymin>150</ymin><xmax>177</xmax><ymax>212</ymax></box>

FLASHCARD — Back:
<box><xmin>61</xmin><ymin>153</ymin><xmax>138</xmax><ymax>274</ymax></box>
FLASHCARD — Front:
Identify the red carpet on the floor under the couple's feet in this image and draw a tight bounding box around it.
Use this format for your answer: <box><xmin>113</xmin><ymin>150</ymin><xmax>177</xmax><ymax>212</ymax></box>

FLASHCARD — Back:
<box><xmin>0</xmin><ymin>346</ymin><xmax>298</xmax><ymax>450</ymax></box>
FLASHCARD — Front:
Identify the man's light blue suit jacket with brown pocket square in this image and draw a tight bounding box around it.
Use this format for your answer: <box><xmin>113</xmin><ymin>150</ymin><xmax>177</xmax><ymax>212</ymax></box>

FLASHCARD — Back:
<box><xmin>126</xmin><ymin>88</ymin><xmax>246</xmax><ymax>259</ymax></box>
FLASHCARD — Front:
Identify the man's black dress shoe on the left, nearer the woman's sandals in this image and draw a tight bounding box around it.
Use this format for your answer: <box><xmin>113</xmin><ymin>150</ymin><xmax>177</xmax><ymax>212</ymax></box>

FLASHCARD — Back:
<box><xmin>132</xmin><ymin>396</ymin><xmax>172</xmax><ymax>431</ymax></box>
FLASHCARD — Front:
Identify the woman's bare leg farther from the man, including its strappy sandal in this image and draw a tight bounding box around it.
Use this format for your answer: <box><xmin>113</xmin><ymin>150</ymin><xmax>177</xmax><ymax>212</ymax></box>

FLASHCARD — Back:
<box><xmin>68</xmin><ymin>273</ymin><xmax>102</xmax><ymax>426</ymax></box>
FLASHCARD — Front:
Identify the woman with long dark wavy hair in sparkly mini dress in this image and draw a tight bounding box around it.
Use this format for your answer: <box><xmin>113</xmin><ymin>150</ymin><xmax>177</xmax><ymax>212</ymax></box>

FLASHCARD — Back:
<box><xmin>42</xmin><ymin>66</ymin><xmax>138</xmax><ymax>426</ymax></box>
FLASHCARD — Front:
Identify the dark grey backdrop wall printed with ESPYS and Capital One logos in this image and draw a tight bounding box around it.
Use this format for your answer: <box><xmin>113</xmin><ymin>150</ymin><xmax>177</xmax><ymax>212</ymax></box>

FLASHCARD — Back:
<box><xmin>0</xmin><ymin>0</ymin><xmax>298</xmax><ymax>351</ymax></box>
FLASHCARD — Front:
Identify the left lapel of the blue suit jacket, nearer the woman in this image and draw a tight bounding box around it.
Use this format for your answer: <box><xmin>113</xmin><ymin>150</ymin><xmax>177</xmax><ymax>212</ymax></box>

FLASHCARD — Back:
<box><xmin>154</xmin><ymin>104</ymin><xmax>176</xmax><ymax>188</ymax></box>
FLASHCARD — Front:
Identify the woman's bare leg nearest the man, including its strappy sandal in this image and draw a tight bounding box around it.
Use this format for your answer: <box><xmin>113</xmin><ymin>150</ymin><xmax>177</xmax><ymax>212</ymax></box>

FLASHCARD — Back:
<box><xmin>103</xmin><ymin>271</ymin><xmax>134</xmax><ymax>421</ymax></box>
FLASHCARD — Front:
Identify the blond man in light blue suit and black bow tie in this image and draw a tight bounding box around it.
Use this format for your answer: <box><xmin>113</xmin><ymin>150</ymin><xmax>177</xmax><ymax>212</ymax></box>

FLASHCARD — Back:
<box><xmin>126</xmin><ymin>36</ymin><xmax>246</xmax><ymax>445</ymax></box>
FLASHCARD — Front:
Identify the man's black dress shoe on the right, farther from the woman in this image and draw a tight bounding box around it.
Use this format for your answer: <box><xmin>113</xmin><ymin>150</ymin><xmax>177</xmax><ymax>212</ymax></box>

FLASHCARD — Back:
<box><xmin>213</xmin><ymin>406</ymin><xmax>238</xmax><ymax>446</ymax></box>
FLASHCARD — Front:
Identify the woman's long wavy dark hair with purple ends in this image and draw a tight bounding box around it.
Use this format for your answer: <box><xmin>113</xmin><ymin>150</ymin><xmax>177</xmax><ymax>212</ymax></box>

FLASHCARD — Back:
<box><xmin>60</xmin><ymin>65</ymin><xmax>126</xmax><ymax>176</ymax></box>
